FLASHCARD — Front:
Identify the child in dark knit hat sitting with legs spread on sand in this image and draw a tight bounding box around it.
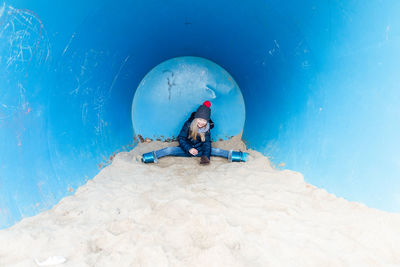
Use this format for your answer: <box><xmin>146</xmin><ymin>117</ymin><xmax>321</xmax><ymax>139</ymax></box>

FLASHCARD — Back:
<box><xmin>142</xmin><ymin>101</ymin><xmax>247</xmax><ymax>164</ymax></box>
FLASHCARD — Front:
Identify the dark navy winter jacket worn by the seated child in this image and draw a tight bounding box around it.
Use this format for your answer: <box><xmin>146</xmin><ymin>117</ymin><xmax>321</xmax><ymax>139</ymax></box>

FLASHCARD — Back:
<box><xmin>178</xmin><ymin>112</ymin><xmax>214</xmax><ymax>158</ymax></box>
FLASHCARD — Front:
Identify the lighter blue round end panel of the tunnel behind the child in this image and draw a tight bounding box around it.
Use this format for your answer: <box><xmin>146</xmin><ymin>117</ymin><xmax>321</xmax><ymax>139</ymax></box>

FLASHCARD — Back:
<box><xmin>132</xmin><ymin>56</ymin><xmax>245</xmax><ymax>141</ymax></box>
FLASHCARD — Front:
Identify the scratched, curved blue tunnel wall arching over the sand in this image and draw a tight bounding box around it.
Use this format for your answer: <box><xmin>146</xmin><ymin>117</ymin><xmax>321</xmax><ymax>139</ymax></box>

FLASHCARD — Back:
<box><xmin>0</xmin><ymin>0</ymin><xmax>400</xmax><ymax>227</ymax></box>
